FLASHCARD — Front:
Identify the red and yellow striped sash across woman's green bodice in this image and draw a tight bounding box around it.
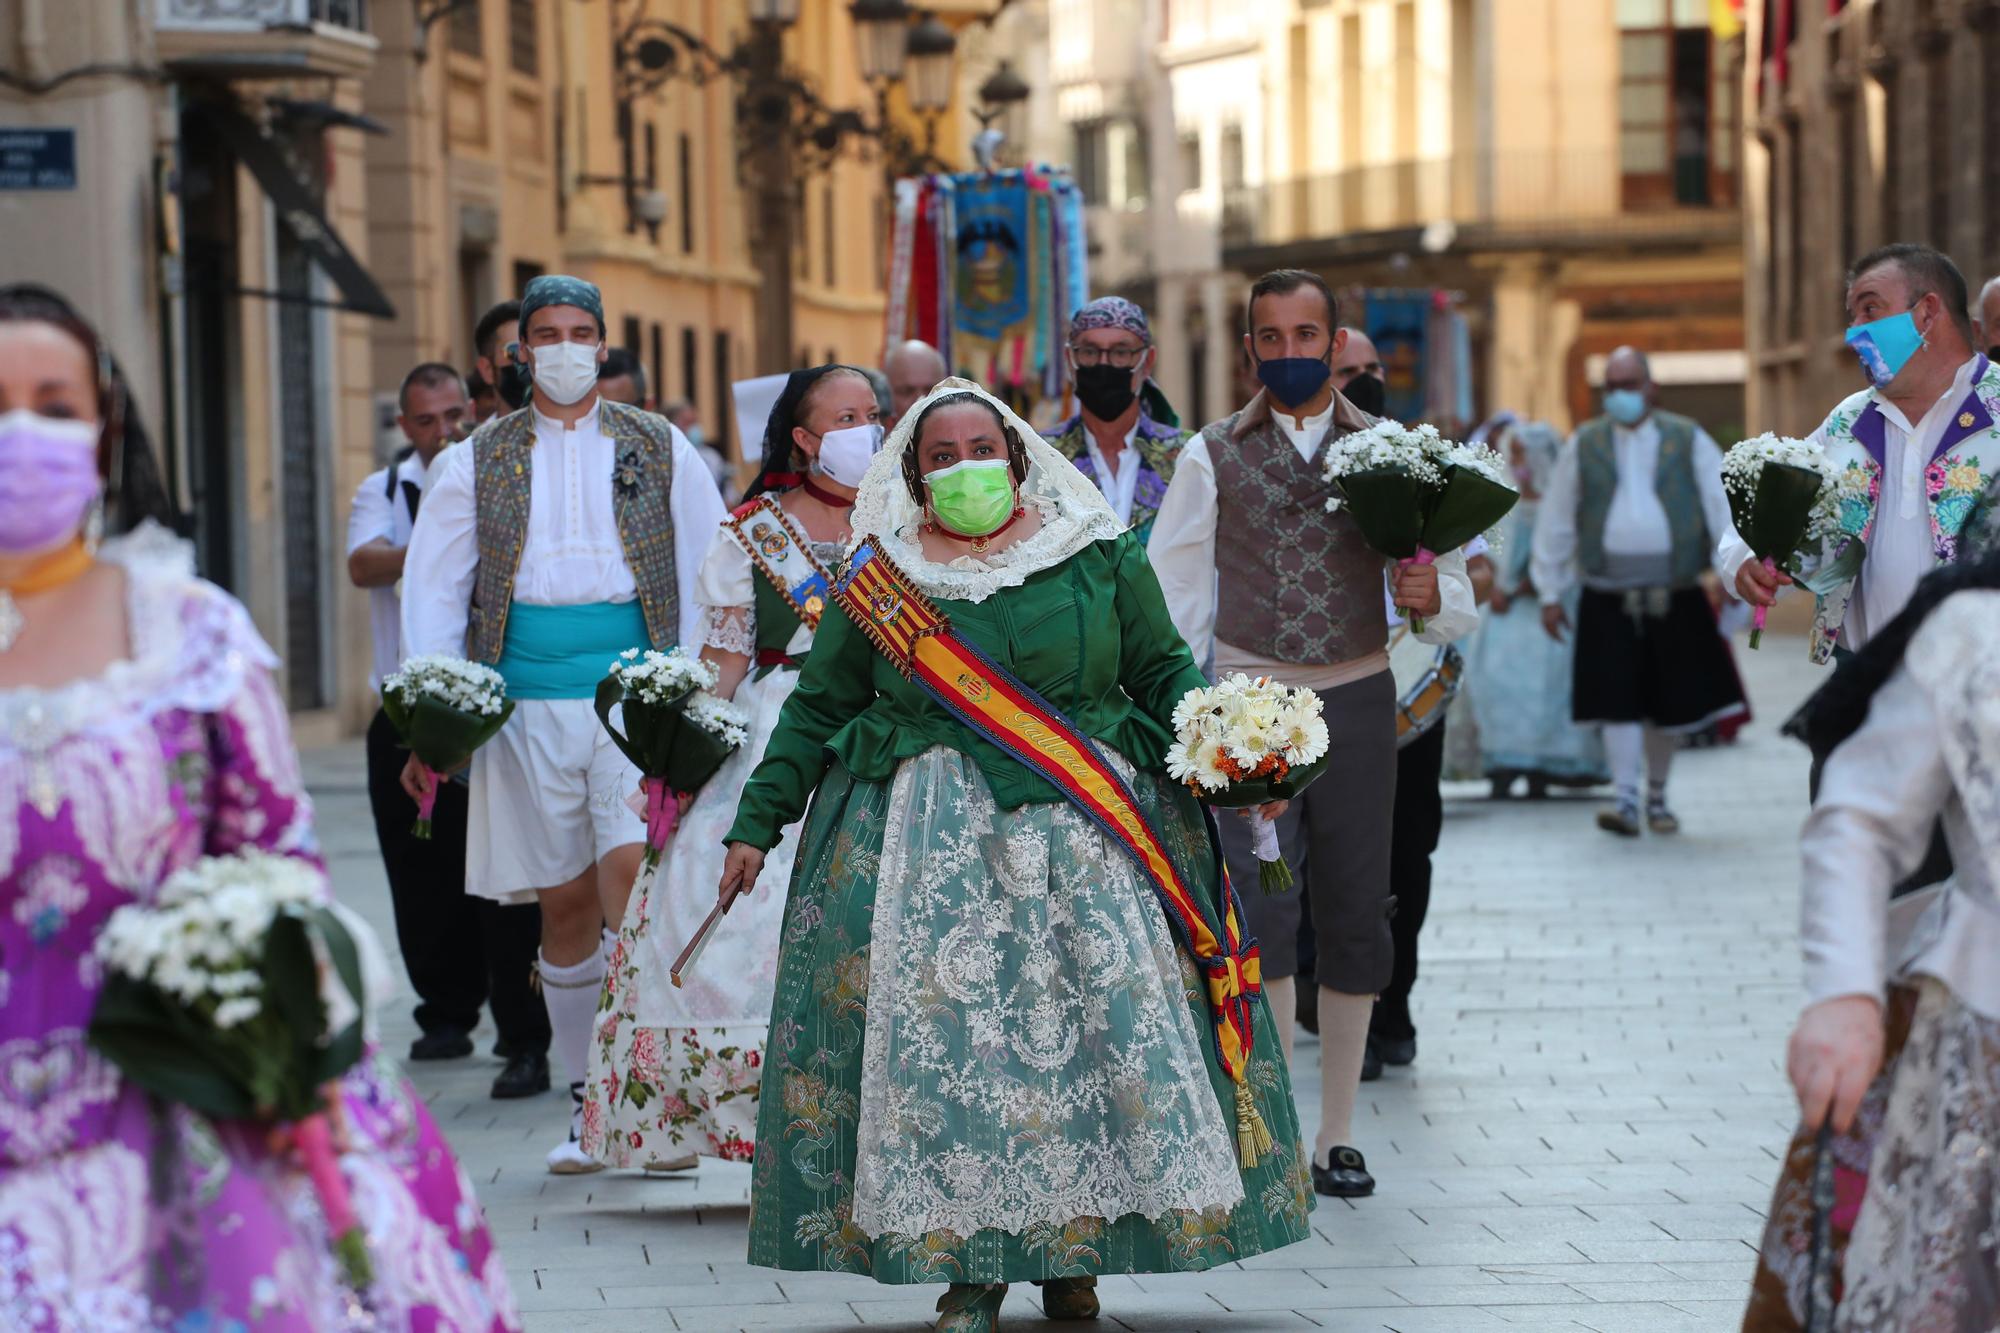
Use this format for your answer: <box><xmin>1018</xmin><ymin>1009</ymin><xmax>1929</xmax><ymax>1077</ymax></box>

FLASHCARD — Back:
<box><xmin>834</xmin><ymin>538</ymin><xmax>1270</xmax><ymax>1169</ymax></box>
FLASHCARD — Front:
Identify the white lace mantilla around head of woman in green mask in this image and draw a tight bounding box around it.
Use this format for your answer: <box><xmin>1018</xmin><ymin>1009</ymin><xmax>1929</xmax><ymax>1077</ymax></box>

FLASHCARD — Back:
<box><xmin>852</xmin><ymin>378</ymin><xmax>1126</xmax><ymax>602</ymax></box>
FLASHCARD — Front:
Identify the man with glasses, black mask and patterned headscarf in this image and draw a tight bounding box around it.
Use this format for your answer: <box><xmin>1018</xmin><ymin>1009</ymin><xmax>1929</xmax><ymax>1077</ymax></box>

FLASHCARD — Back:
<box><xmin>1048</xmin><ymin>296</ymin><xmax>1194</xmax><ymax>540</ymax></box>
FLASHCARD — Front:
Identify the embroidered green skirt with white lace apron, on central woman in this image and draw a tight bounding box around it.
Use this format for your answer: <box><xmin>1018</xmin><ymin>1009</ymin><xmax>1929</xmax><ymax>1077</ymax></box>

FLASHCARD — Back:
<box><xmin>750</xmin><ymin>747</ymin><xmax>1314</xmax><ymax>1283</ymax></box>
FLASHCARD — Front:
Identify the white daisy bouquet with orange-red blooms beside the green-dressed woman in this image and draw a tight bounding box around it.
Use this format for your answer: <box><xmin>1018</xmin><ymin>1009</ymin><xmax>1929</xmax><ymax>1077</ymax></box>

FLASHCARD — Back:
<box><xmin>1166</xmin><ymin>671</ymin><xmax>1328</xmax><ymax>880</ymax></box>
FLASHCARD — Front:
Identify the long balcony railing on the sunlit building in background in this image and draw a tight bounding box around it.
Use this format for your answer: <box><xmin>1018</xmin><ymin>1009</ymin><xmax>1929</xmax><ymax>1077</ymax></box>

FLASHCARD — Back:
<box><xmin>1220</xmin><ymin>148</ymin><xmax>1736</xmax><ymax>250</ymax></box>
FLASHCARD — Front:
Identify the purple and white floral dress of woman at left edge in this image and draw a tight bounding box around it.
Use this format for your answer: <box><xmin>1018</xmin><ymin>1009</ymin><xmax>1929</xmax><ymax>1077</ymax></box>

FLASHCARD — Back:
<box><xmin>0</xmin><ymin>530</ymin><xmax>518</xmax><ymax>1333</ymax></box>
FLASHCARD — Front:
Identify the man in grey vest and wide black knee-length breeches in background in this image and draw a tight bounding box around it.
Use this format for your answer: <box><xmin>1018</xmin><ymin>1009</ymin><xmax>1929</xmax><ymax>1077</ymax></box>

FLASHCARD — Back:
<box><xmin>1530</xmin><ymin>346</ymin><xmax>1744</xmax><ymax>837</ymax></box>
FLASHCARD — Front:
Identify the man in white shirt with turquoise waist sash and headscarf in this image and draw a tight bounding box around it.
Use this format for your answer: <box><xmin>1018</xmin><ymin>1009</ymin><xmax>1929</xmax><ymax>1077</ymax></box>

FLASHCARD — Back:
<box><xmin>402</xmin><ymin>274</ymin><xmax>726</xmax><ymax>1173</ymax></box>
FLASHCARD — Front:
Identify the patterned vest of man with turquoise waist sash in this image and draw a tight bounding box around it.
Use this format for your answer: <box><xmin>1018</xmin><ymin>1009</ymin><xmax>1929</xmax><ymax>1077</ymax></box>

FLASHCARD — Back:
<box><xmin>464</xmin><ymin>398</ymin><xmax>680</xmax><ymax>664</ymax></box>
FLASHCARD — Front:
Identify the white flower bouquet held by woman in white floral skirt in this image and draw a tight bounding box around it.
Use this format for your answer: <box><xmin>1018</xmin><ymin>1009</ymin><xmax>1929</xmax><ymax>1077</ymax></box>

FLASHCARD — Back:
<box><xmin>596</xmin><ymin>646</ymin><xmax>750</xmax><ymax>867</ymax></box>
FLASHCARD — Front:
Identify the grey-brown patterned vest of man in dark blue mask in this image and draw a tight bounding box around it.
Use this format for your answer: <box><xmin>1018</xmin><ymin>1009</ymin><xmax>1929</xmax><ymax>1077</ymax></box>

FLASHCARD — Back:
<box><xmin>1202</xmin><ymin>412</ymin><xmax>1388</xmax><ymax>664</ymax></box>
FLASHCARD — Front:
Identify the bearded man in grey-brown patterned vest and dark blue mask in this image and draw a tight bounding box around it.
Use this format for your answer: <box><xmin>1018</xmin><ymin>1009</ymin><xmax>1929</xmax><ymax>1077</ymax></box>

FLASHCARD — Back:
<box><xmin>1146</xmin><ymin>268</ymin><xmax>1478</xmax><ymax>1197</ymax></box>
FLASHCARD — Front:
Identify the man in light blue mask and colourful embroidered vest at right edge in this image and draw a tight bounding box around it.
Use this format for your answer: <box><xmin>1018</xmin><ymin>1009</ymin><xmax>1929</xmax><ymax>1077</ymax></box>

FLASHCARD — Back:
<box><xmin>1716</xmin><ymin>242</ymin><xmax>2000</xmax><ymax>662</ymax></box>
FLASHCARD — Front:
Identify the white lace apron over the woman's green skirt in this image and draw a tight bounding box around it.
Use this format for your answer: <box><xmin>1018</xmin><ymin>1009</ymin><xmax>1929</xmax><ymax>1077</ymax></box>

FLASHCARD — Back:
<box><xmin>854</xmin><ymin>747</ymin><xmax>1244</xmax><ymax>1237</ymax></box>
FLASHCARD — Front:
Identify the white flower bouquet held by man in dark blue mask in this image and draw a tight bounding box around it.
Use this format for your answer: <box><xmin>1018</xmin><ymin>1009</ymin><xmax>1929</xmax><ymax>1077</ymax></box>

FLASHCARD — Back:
<box><xmin>1322</xmin><ymin>420</ymin><xmax>1520</xmax><ymax>632</ymax></box>
